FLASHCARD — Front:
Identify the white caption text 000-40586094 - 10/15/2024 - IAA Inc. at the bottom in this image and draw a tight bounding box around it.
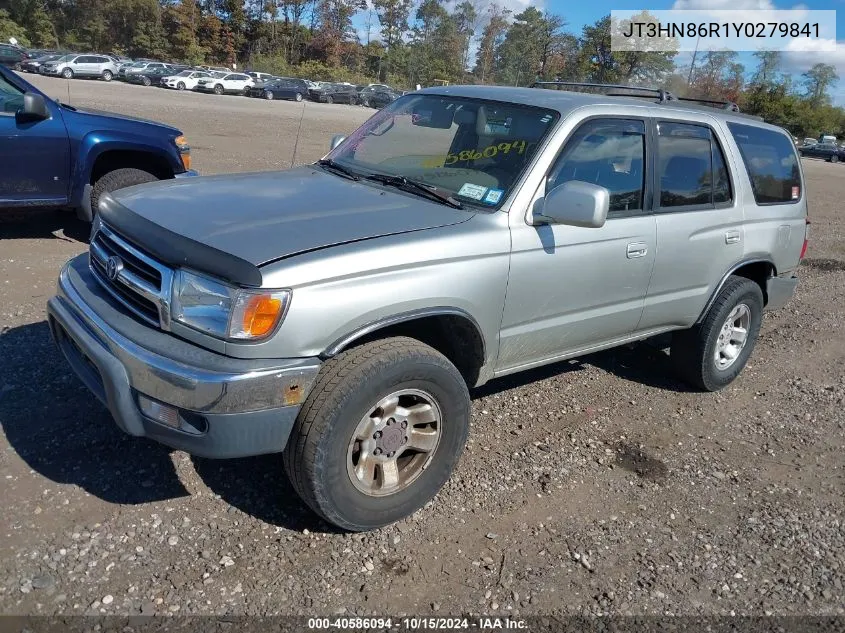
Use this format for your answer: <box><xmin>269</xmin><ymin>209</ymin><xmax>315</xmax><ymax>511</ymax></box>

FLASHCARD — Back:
<box><xmin>308</xmin><ymin>616</ymin><xmax>528</xmax><ymax>632</ymax></box>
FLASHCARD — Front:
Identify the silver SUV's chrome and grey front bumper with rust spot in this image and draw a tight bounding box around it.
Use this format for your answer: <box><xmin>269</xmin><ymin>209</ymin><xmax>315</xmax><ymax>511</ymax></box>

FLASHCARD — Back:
<box><xmin>47</xmin><ymin>254</ymin><xmax>320</xmax><ymax>458</ymax></box>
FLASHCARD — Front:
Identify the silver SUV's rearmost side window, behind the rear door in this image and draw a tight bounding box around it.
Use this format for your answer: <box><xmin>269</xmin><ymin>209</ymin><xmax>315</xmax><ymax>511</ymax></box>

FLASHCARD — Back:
<box><xmin>728</xmin><ymin>123</ymin><xmax>801</xmax><ymax>204</ymax></box>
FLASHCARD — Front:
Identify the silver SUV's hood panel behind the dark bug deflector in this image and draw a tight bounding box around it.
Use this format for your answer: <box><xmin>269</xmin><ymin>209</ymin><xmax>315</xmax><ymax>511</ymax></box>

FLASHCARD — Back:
<box><xmin>106</xmin><ymin>167</ymin><xmax>473</xmax><ymax>266</ymax></box>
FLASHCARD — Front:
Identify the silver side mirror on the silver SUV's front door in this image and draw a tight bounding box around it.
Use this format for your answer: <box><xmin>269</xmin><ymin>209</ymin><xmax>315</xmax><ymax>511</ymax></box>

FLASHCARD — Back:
<box><xmin>533</xmin><ymin>180</ymin><xmax>610</xmax><ymax>229</ymax></box>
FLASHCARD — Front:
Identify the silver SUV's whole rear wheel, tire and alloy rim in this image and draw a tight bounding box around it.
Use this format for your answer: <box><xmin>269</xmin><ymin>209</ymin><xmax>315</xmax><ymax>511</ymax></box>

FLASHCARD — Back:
<box><xmin>671</xmin><ymin>276</ymin><xmax>763</xmax><ymax>391</ymax></box>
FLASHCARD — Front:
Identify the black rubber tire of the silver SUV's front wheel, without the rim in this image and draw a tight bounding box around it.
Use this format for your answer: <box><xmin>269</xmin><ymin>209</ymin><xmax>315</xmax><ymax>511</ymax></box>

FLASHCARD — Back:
<box><xmin>284</xmin><ymin>337</ymin><xmax>470</xmax><ymax>531</ymax></box>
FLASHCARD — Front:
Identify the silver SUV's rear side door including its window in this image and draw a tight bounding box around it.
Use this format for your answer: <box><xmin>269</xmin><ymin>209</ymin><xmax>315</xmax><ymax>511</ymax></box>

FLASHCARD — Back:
<box><xmin>637</xmin><ymin>115</ymin><xmax>745</xmax><ymax>331</ymax></box>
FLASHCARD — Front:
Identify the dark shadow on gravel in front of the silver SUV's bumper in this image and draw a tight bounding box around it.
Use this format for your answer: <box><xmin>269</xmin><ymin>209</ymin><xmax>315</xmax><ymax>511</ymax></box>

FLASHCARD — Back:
<box><xmin>0</xmin><ymin>321</ymin><xmax>188</xmax><ymax>504</ymax></box>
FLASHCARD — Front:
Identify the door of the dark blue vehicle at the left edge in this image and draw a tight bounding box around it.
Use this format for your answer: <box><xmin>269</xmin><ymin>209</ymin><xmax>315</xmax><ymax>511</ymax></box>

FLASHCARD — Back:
<box><xmin>0</xmin><ymin>74</ymin><xmax>70</xmax><ymax>206</ymax></box>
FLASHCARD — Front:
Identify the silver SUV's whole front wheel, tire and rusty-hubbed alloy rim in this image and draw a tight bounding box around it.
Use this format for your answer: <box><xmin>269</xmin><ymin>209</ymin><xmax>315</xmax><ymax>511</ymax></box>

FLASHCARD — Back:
<box><xmin>284</xmin><ymin>337</ymin><xmax>470</xmax><ymax>531</ymax></box>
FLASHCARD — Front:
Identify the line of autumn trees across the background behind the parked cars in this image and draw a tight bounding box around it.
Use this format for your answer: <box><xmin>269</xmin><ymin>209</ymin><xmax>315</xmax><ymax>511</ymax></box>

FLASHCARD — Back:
<box><xmin>0</xmin><ymin>0</ymin><xmax>845</xmax><ymax>137</ymax></box>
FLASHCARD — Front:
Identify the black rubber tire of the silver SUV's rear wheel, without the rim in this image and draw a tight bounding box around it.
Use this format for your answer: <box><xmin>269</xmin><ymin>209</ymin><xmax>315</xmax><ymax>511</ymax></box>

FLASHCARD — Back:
<box><xmin>670</xmin><ymin>276</ymin><xmax>763</xmax><ymax>391</ymax></box>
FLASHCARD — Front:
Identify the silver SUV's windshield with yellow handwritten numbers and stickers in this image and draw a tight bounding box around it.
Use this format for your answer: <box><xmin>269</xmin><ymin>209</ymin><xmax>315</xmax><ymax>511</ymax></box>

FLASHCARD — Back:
<box><xmin>327</xmin><ymin>94</ymin><xmax>559</xmax><ymax>208</ymax></box>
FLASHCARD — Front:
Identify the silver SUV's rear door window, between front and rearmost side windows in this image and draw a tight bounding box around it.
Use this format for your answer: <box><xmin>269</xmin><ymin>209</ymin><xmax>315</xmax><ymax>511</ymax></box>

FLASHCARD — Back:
<box><xmin>657</xmin><ymin>121</ymin><xmax>731</xmax><ymax>210</ymax></box>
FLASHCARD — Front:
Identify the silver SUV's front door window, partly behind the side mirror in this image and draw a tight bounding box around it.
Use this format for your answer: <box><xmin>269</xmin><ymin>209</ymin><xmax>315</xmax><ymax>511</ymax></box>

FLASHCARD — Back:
<box><xmin>546</xmin><ymin>119</ymin><xmax>645</xmax><ymax>217</ymax></box>
